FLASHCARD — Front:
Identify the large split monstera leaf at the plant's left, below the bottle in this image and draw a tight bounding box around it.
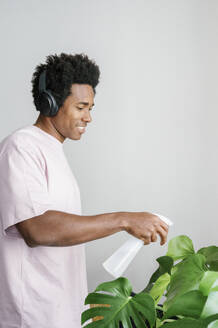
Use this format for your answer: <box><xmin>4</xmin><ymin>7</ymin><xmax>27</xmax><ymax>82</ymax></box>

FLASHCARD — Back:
<box><xmin>82</xmin><ymin>277</ymin><xmax>156</xmax><ymax>328</ymax></box>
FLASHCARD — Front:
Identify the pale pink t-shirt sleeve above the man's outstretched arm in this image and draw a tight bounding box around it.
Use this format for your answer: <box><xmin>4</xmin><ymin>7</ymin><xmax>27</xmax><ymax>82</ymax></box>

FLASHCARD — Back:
<box><xmin>0</xmin><ymin>145</ymin><xmax>51</xmax><ymax>238</ymax></box>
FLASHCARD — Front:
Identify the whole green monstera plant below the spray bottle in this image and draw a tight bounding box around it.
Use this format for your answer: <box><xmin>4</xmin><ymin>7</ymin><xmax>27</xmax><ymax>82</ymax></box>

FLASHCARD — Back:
<box><xmin>81</xmin><ymin>236</ymin><xmax>218</xmax><ymax>328</ymax></box>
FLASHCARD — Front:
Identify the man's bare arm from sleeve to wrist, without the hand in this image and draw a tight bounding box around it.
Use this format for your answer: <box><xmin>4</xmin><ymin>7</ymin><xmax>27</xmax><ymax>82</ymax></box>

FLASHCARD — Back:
<box><xmin>17</xmin><ymin>210</ymin><xmax>128</xmax><ymax>247</ymax></box>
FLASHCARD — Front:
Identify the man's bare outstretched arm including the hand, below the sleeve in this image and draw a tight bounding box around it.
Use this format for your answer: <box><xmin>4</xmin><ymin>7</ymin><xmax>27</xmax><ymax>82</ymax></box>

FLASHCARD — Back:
<box><xmin>16</xmin><ymin>210</ymin><xmax>168</xmax><ymax>247</ymax></box>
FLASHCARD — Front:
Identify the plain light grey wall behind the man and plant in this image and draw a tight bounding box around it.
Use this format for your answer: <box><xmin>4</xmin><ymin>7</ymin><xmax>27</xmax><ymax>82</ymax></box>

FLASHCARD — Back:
<box><xmin>0</xmin><ymin>0</ymin><xmax>218</xmax><ymax>291</ymax></box>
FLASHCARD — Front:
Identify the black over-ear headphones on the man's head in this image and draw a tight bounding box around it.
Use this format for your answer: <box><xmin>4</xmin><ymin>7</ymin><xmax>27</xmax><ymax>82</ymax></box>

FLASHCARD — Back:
<box><xmin>37</xmin><ymin>70</ymin><xmax>59</xmax><ymax>116</ymax></box>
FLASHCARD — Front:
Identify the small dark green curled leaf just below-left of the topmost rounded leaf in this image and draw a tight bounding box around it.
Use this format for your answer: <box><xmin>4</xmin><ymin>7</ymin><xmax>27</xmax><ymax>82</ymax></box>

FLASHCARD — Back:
<box><xmin>143</xmin><ymin>256</ymin><xmax>173</xmax><ymax>293</ymax></box>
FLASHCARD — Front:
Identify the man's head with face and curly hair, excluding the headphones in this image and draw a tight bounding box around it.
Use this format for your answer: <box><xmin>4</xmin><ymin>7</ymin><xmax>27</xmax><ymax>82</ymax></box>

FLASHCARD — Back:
<box><xmin>32</xmin><ymin>53</ymin><xmax>100</xmax><ymax>141</ymax></box>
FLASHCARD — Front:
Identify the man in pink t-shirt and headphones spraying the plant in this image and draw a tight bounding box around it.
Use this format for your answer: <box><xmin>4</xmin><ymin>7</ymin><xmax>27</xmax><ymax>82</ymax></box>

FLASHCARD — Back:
<box><xmin>0</xmin><ymin>54</ymin><xmax>168</xmax><ymax>328</ymax></box>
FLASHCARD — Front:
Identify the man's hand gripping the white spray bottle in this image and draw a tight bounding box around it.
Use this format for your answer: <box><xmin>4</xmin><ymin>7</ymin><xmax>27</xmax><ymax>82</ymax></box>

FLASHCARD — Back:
<box><xmin>123</xmin><ymin>212</ymin><xmax>168</xmax><ymax>245</ymax></box>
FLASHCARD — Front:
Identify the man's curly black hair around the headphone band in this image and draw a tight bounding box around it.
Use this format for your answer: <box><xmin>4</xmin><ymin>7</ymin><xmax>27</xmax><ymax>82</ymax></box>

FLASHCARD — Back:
<box><xmin>31</xmin><ymin>53</ymin><xmax>100</xmax><ymax>110</ymax></box>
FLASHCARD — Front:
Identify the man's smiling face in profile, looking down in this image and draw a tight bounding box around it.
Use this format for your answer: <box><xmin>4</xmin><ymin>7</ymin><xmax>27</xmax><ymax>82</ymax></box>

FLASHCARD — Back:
<box><xmin>51</xmin><ymin>84</ymin><xmax>94</xmax><ymax>140</ymax></box>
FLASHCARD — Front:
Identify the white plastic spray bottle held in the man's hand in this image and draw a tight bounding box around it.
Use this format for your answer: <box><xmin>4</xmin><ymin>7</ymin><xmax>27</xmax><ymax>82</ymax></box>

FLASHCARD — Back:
<box><xmin>103</xmin><ymin>214</ymin><xmax>173</xmax><ymax>278</ymax></box>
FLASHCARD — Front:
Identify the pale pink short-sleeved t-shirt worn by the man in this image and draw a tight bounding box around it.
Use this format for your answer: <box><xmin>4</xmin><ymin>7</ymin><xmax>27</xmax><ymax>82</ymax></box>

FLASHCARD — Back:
<box><xmin>0</xmin><ymin>125</ymin><xmax>87</xmax><ymax>328</ymax></box>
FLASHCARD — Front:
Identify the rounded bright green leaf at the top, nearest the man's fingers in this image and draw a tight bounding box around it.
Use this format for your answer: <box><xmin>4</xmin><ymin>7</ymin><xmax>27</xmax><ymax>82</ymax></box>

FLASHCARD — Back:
<box><xmin>166</xmin><ymin>235</ymin><xmax>195</xmax><ymax>261</ymax></box>
